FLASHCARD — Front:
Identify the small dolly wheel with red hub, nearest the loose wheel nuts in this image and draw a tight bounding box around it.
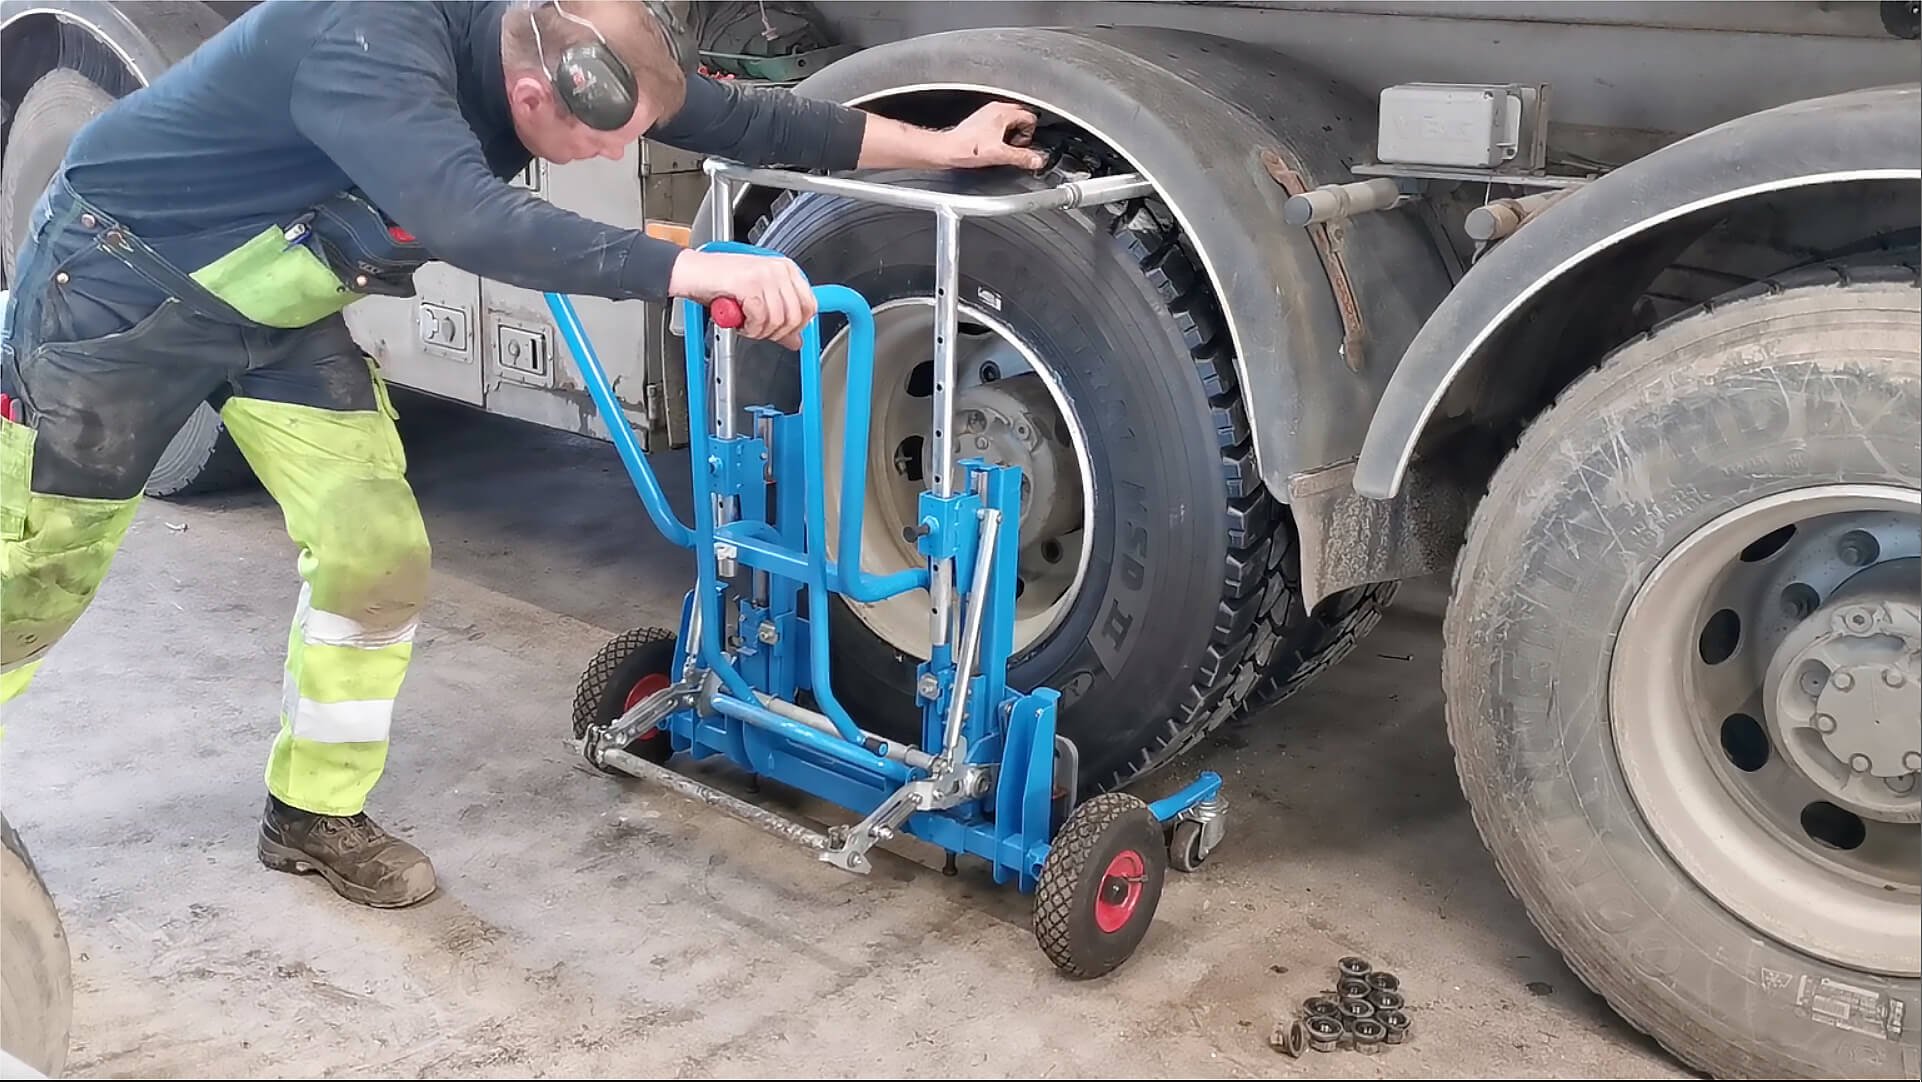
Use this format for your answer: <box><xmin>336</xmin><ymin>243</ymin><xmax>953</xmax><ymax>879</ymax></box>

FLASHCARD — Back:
<box><xmin>1034</xmin><ymin>792</ymin><xmax>1169</xmax><ymax>980</ymax></box>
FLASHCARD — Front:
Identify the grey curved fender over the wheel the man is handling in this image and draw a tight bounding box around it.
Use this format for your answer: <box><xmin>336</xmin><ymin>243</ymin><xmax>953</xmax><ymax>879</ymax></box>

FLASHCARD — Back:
<box><xmin>696</xmin><ymin>27</ymin><xmax>1449</xmax><ymax>502</ymax></box>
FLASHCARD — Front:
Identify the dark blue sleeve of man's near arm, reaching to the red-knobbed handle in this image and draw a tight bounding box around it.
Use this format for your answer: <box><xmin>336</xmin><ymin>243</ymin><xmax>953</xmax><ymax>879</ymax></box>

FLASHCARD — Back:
<box><xmin>280</xmin><ymin>4</ymin><xmax>682</xmax><ymax>300</ymax></box>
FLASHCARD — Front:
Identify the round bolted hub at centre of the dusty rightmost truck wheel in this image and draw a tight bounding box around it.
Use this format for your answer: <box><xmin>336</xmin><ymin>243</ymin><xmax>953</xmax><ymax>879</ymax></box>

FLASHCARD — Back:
<box><xmin>1766</xmin><ymin>559</ymin><xmax>1922</xmax><ymax>823</ymax></box>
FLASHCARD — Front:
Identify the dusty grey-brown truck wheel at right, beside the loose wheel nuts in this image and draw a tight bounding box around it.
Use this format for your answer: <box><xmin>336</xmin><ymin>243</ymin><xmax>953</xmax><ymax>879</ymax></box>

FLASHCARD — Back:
<box><xmin>1443</xmin><ymin>265</ymin><xmax>1922</xmax><ymax>1078</ymax></box>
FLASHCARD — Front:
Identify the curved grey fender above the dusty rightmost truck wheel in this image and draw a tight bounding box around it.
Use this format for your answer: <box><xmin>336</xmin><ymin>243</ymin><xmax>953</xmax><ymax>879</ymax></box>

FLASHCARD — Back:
<box><xmin>1355</xmin><ymin>85</ymin><xmax>1922</xmax><ymax>500</ymax></box>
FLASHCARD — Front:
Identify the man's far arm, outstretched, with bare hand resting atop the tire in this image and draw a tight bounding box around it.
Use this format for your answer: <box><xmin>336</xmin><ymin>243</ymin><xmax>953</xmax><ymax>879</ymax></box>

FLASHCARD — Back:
<box><xmin>648</xmin><ymin>75</ymin><xmax>1044</xmax><ymax>169</ymax></box>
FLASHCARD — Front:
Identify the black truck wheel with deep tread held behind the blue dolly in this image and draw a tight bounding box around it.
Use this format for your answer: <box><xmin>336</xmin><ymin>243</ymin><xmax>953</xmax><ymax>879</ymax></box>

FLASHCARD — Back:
<box><xmin>736</xmin><ymin>146</ymin><xmax>1399</xmax><ymax>790</ymax></box>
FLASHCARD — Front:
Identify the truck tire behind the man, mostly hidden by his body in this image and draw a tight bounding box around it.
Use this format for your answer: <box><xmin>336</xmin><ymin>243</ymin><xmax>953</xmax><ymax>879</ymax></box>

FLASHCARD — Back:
<box><xmin>0</xmin><ymin>67</ymin><xmax>252</xmax><ymax>498</ymax></box>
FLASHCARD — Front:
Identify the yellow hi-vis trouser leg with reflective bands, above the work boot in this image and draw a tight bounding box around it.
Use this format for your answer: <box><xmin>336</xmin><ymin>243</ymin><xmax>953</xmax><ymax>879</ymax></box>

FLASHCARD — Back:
<box><xmin>221</xmin><ymin>394</ymin><xmax>429</xmax><ymax>815</ymax></box>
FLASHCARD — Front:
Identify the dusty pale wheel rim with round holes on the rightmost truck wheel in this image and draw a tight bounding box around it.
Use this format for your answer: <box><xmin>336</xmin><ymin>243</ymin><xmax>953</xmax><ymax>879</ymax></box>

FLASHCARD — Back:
<box><xmin>1611</xmin><ymin>484</ymin><xmax>1922</xmax><ymax>976</ymax></box>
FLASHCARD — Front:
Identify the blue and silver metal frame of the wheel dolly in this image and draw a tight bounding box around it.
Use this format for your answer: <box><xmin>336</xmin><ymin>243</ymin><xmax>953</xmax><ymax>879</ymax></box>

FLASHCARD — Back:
<box><xmin>546</xmin><ymin>160</ymin><xmax>1222</xmax><ymax>892</ymax></box>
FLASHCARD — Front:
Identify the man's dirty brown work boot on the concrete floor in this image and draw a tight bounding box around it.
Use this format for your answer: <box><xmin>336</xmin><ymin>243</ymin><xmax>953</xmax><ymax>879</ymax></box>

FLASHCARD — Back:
<box><xmin>259</xmin><ymin>796</ymin><xmax>434</xmax><ymax>909</ymax></box>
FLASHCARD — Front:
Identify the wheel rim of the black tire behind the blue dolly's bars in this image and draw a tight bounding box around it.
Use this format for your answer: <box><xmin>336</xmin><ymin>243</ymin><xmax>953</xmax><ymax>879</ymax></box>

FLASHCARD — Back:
<box><xmin>821</xmin><ymin>298</ymin><xmax>1094</xmax><ymax>659</ymax></box>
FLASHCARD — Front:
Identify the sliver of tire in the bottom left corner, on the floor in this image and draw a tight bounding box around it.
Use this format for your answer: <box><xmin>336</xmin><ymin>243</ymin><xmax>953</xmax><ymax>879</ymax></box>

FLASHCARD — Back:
<box><xmin>0</xmin><ymin>817</ymin><xmax>73</xmax><ymax>1078</ymax></box>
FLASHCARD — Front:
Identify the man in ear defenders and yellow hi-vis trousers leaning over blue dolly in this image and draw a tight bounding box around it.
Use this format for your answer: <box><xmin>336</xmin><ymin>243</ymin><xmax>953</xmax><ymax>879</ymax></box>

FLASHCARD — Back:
<box><xmin>0</xmin><ymin>0</ymin><xmax>1042</xmax><ymax>907</ymax></box>
